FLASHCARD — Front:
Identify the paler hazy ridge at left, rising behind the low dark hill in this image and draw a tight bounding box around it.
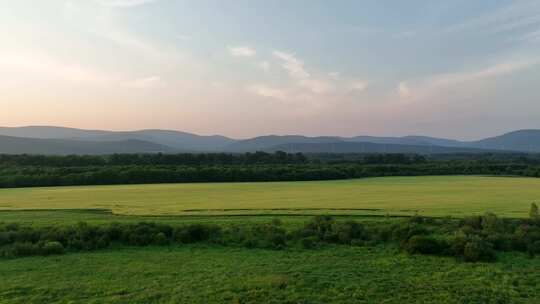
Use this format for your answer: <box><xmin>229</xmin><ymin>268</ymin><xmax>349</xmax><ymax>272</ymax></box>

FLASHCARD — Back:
<box><xmin>0</xmin><ymin>126</ymin><xmax>235</xmax><ymax>151</ymax></box>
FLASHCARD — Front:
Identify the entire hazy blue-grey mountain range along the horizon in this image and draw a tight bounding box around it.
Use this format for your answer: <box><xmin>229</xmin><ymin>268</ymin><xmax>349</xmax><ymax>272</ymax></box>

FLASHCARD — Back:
<box><xmin>0</xmin><ymin>126</ymin><xmax>540</xmax><ymax>155</ymax></box>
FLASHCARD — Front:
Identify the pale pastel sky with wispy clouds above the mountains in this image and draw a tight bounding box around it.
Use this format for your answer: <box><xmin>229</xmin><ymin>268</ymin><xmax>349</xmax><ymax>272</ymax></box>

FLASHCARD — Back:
<box><xmin>0</xmin><ymin>0</ymin><xmax>540</xmax><ymax>139</ymax></box>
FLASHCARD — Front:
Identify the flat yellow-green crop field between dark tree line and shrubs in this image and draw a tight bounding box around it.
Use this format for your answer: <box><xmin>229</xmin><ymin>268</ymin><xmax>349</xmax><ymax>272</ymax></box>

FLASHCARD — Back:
<box><xmin>0</xmin><ymin>176</ymin><xmax>540</xmax><ymax>217</ymax></box>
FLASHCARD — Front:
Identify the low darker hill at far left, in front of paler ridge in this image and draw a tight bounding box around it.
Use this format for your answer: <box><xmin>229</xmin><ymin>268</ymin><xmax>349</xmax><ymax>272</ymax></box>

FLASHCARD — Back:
<box><xmin>0</xmin><ymin>136</ymin><xmax>173</xmax><ymax>155</ymax></box>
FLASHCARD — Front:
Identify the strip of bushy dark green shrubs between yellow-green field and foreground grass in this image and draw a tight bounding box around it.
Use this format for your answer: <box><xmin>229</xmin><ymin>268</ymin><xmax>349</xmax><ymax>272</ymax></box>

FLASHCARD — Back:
<box><xmin>0</xmin><ymin>213</ymin><xmax>540</xmax><ymax>262</ymax></box>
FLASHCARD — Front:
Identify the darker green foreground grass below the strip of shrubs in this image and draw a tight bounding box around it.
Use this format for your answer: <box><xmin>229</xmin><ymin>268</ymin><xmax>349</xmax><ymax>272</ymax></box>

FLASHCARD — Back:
<box><xmin>0</xmin><ymin>246</ymin><xmax>540</xmax><ymax>303</ymax></box>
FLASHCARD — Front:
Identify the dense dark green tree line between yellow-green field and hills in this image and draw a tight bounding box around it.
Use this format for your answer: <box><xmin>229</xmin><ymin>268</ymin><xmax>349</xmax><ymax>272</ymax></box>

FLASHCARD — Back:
<box><xmin>0</xmin><ymin>152</ymin><xmax>540</xmax><ymax>188</ymax></box>
